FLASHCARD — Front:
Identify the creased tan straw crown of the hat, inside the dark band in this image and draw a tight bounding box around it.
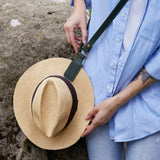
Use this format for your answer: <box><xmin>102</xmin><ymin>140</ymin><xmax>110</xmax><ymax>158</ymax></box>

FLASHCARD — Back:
<box><xmin>32</xmin><ymin>77</ymin><xmax>72</xmax><ymax>137</ymax></box>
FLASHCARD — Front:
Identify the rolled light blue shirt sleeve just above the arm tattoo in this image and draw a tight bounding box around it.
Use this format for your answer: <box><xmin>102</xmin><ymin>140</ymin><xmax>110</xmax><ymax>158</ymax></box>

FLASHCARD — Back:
<box><xmin>145</xmin><ymin>47</ymin><xmax>160</xmax><ymax>80</ymax></box>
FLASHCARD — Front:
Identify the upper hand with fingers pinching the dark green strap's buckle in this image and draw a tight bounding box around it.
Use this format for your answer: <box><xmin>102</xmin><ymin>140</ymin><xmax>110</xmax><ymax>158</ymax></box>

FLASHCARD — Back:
<box><xmin>64</xmin><ymin>2</ymin><xmax>87</xmax><ymax>53</ymax></box>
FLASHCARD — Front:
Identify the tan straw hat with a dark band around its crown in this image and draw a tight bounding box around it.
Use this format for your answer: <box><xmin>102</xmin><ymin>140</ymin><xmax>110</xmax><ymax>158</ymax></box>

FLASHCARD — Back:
<box><xmin>13</xmin><ymin>58</ymin><xmax>94</xmax><ymax>150</ymax></box>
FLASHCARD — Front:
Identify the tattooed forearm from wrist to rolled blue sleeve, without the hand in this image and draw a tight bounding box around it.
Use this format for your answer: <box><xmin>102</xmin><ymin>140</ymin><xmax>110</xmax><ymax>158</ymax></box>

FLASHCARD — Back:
<box><xmin>113</xmin><ymin>68</ymin><xmax>156</xmax><ymax>109</ymax></box>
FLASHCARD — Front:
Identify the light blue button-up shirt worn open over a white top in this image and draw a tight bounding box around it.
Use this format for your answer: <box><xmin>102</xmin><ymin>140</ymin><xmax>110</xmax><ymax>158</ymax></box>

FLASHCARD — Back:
<box><xmin>70</xmin><ymin>0</ymin><xmax>160</xmax><ymax>142</ymax></box>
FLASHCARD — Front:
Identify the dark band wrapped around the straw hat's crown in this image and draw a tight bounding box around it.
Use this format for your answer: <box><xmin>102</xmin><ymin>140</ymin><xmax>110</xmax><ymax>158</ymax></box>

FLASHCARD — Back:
<box><xmin>31</xmin><ymin>75</ymin><xmax>78</xmax><ymax>129</ymax></box>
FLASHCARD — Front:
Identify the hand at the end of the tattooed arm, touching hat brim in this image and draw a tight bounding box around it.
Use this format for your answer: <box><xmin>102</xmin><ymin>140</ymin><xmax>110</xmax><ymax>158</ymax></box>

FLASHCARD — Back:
<box><xmin>82</xmin><ymin>97</ymin><xmax>119</xmax><ymax>137</ymax></box>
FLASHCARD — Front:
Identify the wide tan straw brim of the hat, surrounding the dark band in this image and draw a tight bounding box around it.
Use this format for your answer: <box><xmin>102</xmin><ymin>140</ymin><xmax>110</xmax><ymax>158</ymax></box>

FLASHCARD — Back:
<box><xmin>13</xmin><ymin>58</ymin><xmax>94</xmax><ymax>150</ymax></box>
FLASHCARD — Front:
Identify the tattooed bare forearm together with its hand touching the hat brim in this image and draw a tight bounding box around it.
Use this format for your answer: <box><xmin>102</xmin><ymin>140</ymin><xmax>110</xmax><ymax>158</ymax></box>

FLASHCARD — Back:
<box><xmin>82</xmin><ymin>69</ymin><xmax>156</xmax><ymax>137</ymax></box>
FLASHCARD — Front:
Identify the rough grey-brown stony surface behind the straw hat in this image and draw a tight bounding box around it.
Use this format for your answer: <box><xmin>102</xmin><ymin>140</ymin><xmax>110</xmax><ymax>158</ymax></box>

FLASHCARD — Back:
<box><xmin>0</xmin><ymin>0</ymin><xmax>87</xmax><ymax>160</ymax></box>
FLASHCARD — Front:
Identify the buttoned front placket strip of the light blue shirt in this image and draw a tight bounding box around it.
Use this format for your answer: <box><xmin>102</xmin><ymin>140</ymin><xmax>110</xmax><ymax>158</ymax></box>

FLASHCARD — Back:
<box><xmin>106</xmin><ymin>2</ymin><xmax>129</xmax><ymax>97</ymax></box>
